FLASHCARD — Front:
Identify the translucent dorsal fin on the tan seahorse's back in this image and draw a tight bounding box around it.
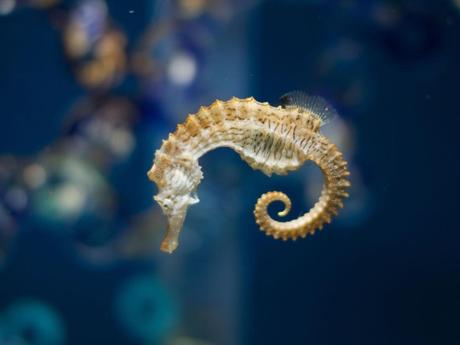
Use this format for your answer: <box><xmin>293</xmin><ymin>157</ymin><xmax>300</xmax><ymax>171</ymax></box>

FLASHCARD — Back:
<box><xmin>280</xmin><ymin>90</ymin><xmax>337</xmax><ymax>125</ymax></box>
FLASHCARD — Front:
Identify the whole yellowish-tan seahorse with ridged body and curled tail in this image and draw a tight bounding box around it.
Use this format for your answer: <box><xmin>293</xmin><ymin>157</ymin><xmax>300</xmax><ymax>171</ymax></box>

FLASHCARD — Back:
<box><xmin>147</xmin><ymin>93</ymin><xmax>350</xmax><ymax>253</ymax></box>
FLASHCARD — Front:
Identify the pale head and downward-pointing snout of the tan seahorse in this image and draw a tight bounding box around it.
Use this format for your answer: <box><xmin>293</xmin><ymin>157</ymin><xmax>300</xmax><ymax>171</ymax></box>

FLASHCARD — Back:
<box><xmin>147</xmin><ymin>152</ymin><xmax>202</xmax><ymax>253</ymax></box>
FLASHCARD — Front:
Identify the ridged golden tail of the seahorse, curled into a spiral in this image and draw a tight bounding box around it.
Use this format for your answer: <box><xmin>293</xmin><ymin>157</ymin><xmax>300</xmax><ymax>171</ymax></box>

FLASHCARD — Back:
<box><xmin>254</xmin><ymin>138</ymin><xmax>350</xmax><ymax>240</ymax></box>
